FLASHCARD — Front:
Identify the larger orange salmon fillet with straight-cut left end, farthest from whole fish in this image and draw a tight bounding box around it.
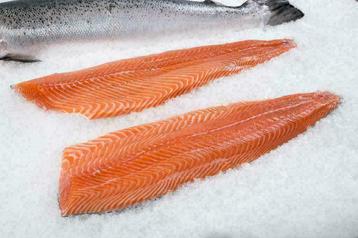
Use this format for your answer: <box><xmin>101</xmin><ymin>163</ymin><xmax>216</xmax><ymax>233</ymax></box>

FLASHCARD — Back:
<box><xmin>59</xmin><ymin>92</ymin><xmax>339</xmax><ymax>216</ymax></box>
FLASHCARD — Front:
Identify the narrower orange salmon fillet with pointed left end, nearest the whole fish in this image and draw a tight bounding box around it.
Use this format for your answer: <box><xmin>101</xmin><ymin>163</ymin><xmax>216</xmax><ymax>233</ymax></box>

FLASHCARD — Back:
<box><xmin>13</xmin><ymin>39</ymin><xmax>295</xmax><ymax>119</ymax></box>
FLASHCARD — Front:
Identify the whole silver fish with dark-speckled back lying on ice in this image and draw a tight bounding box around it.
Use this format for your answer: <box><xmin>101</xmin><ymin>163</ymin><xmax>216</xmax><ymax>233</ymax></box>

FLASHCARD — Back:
<box><xmin>0</xmin><ymin>0</ymin><xmax>303</xmax><ymax>61</ymax></box>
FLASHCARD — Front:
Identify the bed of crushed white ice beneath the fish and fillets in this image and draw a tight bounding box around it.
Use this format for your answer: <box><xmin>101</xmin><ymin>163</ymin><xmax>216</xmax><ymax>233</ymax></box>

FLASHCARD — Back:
<box><xmin>0</xmin><ymin>0</ymin><xmax>358</xmax><ymax>238</ymax></box>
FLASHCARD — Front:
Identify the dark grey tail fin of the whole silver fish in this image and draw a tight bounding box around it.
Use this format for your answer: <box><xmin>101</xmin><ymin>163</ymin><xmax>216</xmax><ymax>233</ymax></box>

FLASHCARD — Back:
<box><xmin>250</xmin><ymin>0</ymin><xmax>304</xmax><ymax>26</ymax></box>
